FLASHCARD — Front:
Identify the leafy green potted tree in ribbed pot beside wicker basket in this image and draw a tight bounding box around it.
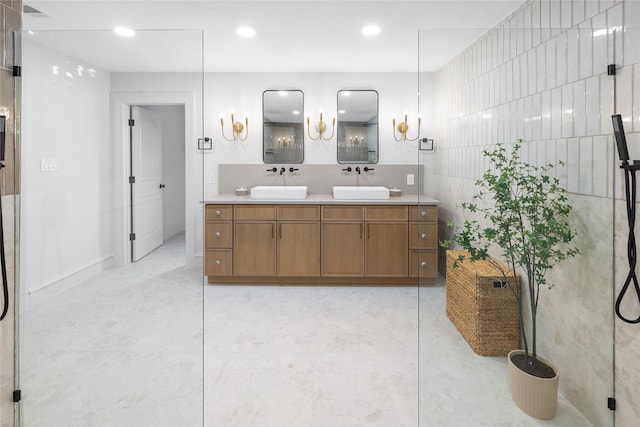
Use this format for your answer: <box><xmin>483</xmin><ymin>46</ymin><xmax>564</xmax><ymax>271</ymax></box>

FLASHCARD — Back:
<box><xmin>443</xmin><ymin>140</ymin><xmax>579</xmax><ymax>419</ymax></box>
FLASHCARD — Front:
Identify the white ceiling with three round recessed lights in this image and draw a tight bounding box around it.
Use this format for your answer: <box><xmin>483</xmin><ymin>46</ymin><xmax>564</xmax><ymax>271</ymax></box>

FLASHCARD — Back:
<box><xmin>23</xmin><ymin>0</ymin><xmax>523</xmax><ymax>72</ymax></box>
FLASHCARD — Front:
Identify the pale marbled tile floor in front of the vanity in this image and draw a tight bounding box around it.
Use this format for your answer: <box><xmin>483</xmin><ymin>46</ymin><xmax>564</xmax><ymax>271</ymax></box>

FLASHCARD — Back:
<box><xmin>21</xmin><ymin>236</ymin><xmax>589</xmax><ymax>427</ymax></box>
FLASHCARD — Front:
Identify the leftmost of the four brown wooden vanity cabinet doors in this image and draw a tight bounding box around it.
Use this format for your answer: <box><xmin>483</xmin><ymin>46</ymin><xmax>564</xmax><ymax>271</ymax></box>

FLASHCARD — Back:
<box><xmin>233</xmin><ymin>221</ymin><xmax>276</xmax><ymax>276</ymax></box>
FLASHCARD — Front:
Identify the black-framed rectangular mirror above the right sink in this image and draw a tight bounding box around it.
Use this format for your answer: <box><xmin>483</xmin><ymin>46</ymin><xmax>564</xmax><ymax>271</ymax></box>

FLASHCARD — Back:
<box><xmin>338</xmin><ymin>90</ymin><xmax>378</xmax><ymax>163</ymax></box>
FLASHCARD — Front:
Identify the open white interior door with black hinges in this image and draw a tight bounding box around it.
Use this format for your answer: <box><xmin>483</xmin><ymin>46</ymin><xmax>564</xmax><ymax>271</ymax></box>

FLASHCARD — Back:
<box><xmin>131</xmin><ymin>106</ymin><xmax>163</xmax><ymax>261</ymax></box>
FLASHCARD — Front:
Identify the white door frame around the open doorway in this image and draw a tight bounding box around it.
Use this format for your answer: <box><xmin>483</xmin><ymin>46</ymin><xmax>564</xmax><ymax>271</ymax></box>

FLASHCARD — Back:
<box><xmin>111</xmin><ymin>92</ymin><xmax>202</xmax><ymax>266</ymax></box>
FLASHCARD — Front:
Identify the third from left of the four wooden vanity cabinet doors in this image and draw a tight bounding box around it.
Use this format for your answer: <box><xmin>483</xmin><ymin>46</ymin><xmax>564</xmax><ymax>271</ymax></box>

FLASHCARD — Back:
<box><xmin>322</xmin><ymin>222</ymin><xmax>364</xmax><ymax>277</ymax></box>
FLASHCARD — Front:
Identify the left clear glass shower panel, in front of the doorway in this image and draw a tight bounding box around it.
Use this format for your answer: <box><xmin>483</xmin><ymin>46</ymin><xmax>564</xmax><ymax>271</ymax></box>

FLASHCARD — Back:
<box><xmin>20</xmin><ymin>30</ymin><xmax>204</xmax><ymax>427</ymax></box>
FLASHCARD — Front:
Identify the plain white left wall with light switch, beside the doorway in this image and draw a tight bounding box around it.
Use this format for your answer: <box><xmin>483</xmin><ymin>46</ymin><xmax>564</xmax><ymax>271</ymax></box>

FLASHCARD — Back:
<box><xmin>20</xmin><ymin>40</ymin><xmax>113</xmax><ymax>309</ymax></box>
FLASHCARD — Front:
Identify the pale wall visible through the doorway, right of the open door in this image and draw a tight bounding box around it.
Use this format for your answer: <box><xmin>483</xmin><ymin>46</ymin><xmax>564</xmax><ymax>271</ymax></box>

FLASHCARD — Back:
<box><xmin>146</xmin><ymin>105</ymin><xmax>185</xmax><ymax>240</ymax></box>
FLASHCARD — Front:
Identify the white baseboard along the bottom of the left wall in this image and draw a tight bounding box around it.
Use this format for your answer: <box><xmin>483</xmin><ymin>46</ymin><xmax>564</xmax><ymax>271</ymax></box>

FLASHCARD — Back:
<box><xmin>22</xmin><ymin>255</ymin><xmax>113</xmax><ymax>310</ymax></box>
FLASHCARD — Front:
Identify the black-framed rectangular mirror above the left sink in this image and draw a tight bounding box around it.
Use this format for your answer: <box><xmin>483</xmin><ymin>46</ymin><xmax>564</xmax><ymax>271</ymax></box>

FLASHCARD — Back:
<box><xmin>262</xmin><ymin>90</ymin><xmax>304</xmax><ymax>163</ymax></box>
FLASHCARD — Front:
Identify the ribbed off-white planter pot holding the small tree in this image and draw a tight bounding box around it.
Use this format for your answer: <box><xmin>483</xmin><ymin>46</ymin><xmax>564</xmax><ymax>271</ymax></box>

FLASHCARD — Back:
<box><xmin>507</xmin><ymin>350</ymin><xmax>560</xmax><ymax>420</ymax></box>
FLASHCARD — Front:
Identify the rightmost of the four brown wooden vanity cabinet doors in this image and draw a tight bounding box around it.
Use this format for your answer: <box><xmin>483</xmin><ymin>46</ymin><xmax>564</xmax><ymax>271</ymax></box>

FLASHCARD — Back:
<box><xmin>365</xmin><ymin>222</ymin><xmax>408</xmax><ymax>277</ymax></box>
